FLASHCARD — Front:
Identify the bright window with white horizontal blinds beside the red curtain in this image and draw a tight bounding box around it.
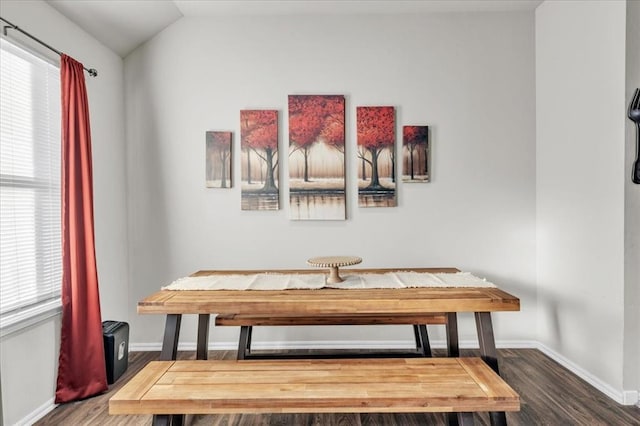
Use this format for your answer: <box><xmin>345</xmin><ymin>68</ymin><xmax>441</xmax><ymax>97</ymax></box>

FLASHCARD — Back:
<box><xmin>0</xmin><ymin>39</ymin><xmax>62</xmax><ymax>329</ymax></box>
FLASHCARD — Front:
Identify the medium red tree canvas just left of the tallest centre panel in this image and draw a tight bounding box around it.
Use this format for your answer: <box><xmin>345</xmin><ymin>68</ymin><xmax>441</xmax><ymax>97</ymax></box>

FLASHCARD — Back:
<box><xmin>240</xmin><ymin>110</ymin><xmax>280</xmax><ymax>210</ymax></box>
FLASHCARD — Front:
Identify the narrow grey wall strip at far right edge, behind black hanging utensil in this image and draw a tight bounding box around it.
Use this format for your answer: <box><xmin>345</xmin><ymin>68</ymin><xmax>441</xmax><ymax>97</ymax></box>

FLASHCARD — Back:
<box><xmin>624</xmin><ymin>1</ymin><xmax>640</xmax><ymax>400</ymax></box>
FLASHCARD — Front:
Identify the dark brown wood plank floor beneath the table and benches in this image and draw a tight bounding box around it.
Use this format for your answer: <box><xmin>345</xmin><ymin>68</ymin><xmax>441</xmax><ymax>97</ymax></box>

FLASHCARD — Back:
<box><xmin>36</xmin><ymin>349</ymin><xmax>640</xmax><ymax>426</ymax></box>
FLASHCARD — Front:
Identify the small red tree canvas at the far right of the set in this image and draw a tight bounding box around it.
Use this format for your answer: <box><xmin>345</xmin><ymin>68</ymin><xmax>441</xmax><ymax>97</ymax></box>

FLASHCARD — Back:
<box><xmin>402</xmin><ymin>126</ymin><xmax>429</xmax><ymax>183</ymax></box>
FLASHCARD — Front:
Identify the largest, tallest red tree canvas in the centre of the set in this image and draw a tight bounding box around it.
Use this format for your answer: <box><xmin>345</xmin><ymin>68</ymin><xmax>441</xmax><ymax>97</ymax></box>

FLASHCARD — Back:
<box><xmin>289</xmin><ymin>95</ymin><xmax>346</xmax><ymax>220</ymax></box>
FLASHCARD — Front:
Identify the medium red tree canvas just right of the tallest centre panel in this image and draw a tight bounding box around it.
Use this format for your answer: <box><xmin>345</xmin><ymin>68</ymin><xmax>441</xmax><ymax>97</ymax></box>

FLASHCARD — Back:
<box><xmin>356</xmin><ymin>106</ymin><xmax>396</xmax><ymax>207</ymax></box>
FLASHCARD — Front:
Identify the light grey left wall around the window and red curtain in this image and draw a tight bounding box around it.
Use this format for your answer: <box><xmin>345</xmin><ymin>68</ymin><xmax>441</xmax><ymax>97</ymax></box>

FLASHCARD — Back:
<box><xmin>0</xmin><ymin>0</ymin><xmax>129</xmax><ymax>425</ymax></box>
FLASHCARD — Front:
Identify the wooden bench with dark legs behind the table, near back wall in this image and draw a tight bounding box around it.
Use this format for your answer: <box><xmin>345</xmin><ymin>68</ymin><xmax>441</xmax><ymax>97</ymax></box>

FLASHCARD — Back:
<box><xmin>215</xmin><ymin>313</ymin><xmax>450</xmax><ymax>359</ymax></box>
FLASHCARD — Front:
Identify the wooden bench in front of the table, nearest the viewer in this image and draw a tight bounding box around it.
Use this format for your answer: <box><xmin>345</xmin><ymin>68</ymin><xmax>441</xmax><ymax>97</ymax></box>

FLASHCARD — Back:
<box><xmin>109</xmin><ymin>358</ymin><xmax>520</xmax><ymax>425</ymax></box>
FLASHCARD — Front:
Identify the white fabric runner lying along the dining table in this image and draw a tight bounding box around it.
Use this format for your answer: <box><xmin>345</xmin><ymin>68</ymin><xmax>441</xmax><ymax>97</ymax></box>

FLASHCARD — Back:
<box><xmin>162</xmin><ymin>271</ymin><xmax>495</xmax><ymax>290</ymax></box>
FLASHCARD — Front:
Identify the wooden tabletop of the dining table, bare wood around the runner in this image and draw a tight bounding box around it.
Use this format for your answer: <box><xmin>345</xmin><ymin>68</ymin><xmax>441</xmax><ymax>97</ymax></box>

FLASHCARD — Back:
<box><xmin>138</xmin><ymin>268</ymin><xmax>520</xmax><ymax>317</ymax></box>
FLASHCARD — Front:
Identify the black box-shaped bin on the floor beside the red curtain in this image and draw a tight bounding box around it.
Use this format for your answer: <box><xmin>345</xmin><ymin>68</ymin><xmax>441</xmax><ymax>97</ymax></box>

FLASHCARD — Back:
<box><xmin>102</xmin><ymin>321</ymin><xmax>129</xmax><ymax>384</ymax></box>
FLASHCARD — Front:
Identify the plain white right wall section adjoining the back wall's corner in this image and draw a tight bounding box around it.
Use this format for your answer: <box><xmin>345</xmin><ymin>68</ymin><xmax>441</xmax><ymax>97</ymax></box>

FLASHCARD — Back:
<box><xmin>535</xmin><ymin>1</ymin><xmax>637</xmax><ymax>397</ymax></box>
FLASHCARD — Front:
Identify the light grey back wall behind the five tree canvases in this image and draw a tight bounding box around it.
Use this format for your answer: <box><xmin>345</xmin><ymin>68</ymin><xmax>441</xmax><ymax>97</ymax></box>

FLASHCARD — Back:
<box><xmin>125</xmin><ymin>12</ymin><xmax>536</xmax><ymax>347</ymax></box>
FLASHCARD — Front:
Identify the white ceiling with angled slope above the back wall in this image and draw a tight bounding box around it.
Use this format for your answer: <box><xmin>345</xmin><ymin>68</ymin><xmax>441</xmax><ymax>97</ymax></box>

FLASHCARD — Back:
<box><xmin>46</xmin><ymin>0</ymin><xmax>542</xmax><ymax>58</ymax></box>
